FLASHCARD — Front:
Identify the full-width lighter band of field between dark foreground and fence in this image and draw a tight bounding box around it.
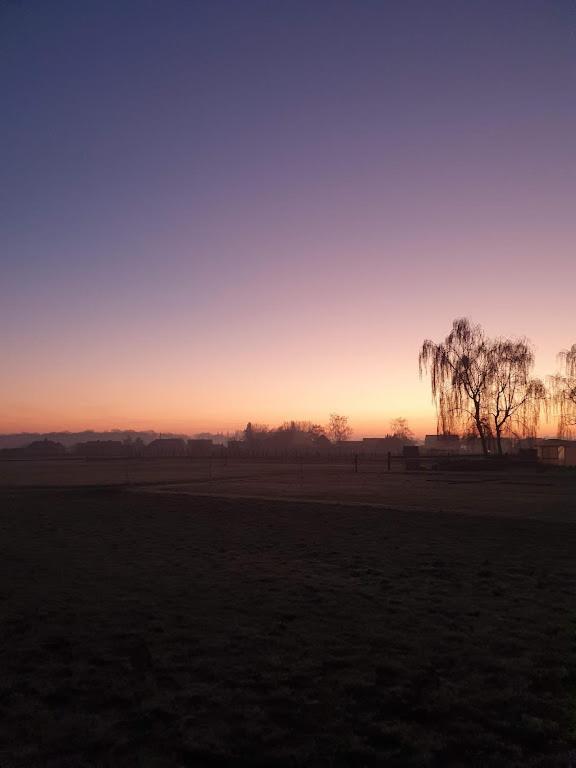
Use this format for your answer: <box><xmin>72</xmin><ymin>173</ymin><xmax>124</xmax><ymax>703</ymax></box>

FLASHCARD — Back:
<box><xmin>0</xmin><ymin>458</ymin><xmax>576</xmax><ymax>521</ymax></box>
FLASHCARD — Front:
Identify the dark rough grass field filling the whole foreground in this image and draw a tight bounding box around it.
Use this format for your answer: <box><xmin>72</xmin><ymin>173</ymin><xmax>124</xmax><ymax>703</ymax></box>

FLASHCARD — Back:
<box><xmin>0</xmin><ymin>488</ymin><xmax>576</xmax><ymax>768</ymax></box>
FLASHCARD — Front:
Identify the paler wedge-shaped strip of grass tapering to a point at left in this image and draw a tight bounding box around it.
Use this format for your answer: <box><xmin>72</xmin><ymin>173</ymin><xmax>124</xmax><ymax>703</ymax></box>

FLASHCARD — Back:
<box><xmin>152</xmin><ymin>465</ymin><xmax>576</xmax><ymax>521</ymax></box>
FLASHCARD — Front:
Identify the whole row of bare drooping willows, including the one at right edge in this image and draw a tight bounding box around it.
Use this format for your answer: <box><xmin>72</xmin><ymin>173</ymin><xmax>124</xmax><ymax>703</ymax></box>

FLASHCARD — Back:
<box><xmin>419</xmin><ymin>318</ymin><xmax>576</xmax><ymax>455</ymax></box>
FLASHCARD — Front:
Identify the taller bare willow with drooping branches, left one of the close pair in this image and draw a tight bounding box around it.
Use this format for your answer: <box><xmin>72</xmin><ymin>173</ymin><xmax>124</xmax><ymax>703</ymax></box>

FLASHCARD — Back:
<box><xmin>418</xmin><ymin>317</ymin><xmax>494</xmax><ymax>455</ymax></box>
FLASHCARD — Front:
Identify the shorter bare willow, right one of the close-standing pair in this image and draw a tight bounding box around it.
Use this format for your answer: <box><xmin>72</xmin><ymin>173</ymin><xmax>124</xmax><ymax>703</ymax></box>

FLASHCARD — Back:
<box><xmin>485</xmin><ymin>339</ymin><xmax>546</xmax><ymax>456</ymax></box>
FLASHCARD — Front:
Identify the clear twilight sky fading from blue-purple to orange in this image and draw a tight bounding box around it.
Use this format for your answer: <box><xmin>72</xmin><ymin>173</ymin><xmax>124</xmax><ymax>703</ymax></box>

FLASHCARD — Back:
<box><xmin>0</xmin><ymin>0</ymin><xmax>576</xmax><ymax>436</ymax></box>
